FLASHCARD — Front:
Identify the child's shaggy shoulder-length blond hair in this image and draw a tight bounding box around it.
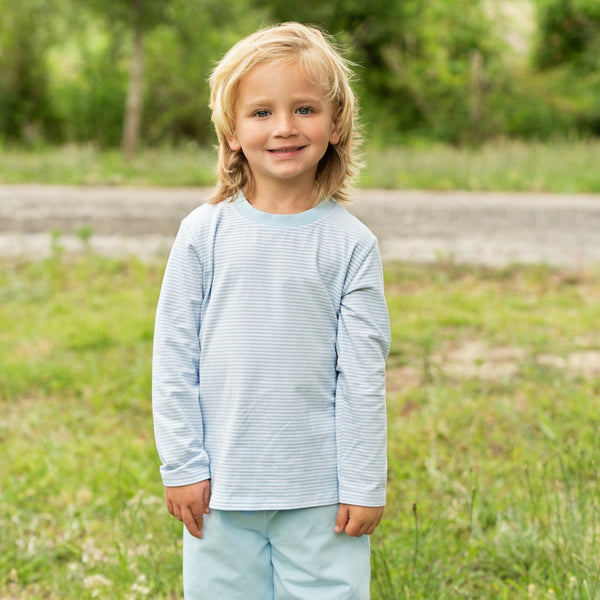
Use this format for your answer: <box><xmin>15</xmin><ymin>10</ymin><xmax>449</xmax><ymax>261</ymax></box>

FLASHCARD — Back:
<box><xmin>209</xmin><ymin>23</ymin><xmax>360</xmax><ymax>203</ymax></box>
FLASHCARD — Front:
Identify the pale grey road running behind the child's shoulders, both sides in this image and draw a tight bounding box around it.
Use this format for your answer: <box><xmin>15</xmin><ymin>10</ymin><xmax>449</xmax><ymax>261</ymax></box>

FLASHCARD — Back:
<box><xmin>0</xmin><ymin>185</ymin><xmax>600</xmax><ymax>268</ymax></box>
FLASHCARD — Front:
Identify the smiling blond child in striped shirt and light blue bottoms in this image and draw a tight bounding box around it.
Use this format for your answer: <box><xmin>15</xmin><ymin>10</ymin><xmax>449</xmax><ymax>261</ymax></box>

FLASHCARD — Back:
<box><xmin>153</xmin><ymin>23</ymin><xmax>390</xmax><ymax>600</ymax></box>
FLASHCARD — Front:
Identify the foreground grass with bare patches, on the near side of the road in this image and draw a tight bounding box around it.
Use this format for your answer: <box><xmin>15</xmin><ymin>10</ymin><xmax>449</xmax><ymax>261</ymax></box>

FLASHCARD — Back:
<box><xmin>0</xmin><ymin>249</ymin><xmax>600</xmax><ymax>600</ymax></box>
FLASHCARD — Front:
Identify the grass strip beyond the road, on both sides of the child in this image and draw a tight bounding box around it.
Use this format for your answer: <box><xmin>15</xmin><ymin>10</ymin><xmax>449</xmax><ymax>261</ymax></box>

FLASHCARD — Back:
<box><xmin>0</xmin><ymin>140</ymin><xmax>600</xmax><ymax>193</ymax></box>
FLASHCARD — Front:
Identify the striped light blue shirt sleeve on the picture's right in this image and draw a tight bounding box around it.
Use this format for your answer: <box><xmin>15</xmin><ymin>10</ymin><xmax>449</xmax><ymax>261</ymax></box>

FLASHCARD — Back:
<box><xmin>335</xmin><ymin>243</ymin><xmax>390</xmax><ymax>507</ymax></box>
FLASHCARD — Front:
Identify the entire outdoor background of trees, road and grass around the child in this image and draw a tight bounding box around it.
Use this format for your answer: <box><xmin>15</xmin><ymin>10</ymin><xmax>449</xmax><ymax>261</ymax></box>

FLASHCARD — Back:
<box><xmin>0</xmin><ymin>0</ymin><xmax>600</xmax><ymax>600</ymax></box>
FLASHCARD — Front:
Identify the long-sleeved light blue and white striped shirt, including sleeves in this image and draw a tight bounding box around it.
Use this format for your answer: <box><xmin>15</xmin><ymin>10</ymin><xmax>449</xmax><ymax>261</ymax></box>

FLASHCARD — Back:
<box><xmin>153</xmin><ymin>196</ymin><xmax>390</xmax><ymax>510</ymax></box>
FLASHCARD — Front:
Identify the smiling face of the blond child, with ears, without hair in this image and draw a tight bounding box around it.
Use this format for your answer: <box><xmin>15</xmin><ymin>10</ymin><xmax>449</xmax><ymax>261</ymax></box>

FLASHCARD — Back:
<box><xmin>227</xmin><ymin>63</ymin><xmax>340</xmax><ymax>200</ymax></box>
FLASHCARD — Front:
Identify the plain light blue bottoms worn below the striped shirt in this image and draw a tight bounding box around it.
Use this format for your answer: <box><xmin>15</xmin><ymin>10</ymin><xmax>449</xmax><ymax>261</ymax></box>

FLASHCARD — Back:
<box><xmin>183</xmin><ymin>504</ymin><xmax>371</xmax><ymax>600</ymax></box>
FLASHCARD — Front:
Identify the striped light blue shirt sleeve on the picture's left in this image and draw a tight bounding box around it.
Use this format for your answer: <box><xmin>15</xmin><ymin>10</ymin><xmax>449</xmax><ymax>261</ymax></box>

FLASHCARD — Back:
<box><xmin>152</xmin><ymin>223</ymin><xmax>210</xmax><ymax>486</ymax></box>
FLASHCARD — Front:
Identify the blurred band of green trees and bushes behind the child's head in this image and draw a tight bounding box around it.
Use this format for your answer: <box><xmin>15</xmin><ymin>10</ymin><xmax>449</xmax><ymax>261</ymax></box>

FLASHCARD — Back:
<box><xmin>0</xmin><ymin>0</ymin><xmax>600</xmax><ymax>155</ymax></box>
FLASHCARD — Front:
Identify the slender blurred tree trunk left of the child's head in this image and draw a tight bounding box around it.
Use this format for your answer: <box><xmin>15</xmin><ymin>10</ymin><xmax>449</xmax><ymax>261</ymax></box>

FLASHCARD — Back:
<box><xmin>121</xmin><ymin>0</ymin><xmax>144</xmax><ymax>158</ymax></box>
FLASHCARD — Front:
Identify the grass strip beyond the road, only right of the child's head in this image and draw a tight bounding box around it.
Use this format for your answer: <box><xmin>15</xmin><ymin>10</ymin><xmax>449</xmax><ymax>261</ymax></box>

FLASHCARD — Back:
<box><xmin>361</xmin><ymin>140</ymin><xmax>600</xmax><ymax>193</ymax></box>
